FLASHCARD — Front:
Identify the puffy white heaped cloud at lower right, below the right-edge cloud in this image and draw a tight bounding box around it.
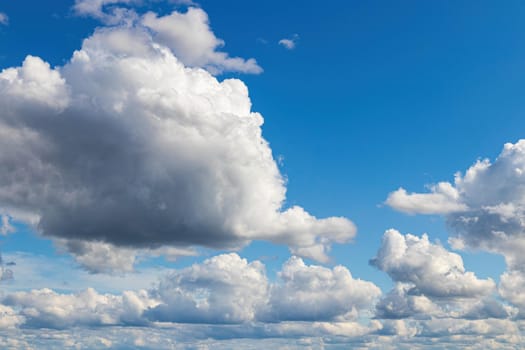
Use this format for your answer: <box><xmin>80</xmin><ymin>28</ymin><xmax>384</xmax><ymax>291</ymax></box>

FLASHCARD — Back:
<box><xmin>371</xmin><ymin>229</ymin><xmax>508</xmax><ymax>331</ymax></box>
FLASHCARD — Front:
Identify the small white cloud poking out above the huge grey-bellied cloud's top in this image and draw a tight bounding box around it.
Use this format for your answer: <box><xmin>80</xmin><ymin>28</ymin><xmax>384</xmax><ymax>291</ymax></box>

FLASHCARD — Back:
<box><xmin>142</xmin><ymin>7</ymin><xmax>262</xmax><ymax>74</ymax></box>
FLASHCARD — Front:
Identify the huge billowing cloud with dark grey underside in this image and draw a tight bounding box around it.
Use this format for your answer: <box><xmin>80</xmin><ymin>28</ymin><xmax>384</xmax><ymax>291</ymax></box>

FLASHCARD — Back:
<box><xmin>0</xmin><ymin>18</ymin><xmax>355</xmax><ymax>271</ymax></box>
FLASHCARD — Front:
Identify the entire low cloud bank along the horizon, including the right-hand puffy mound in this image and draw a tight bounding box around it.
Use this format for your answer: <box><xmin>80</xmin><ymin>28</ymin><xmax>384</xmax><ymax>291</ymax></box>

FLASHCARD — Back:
<box><xmin>0</xmin><ymin>247</ymin><xmax>521</xmax><ymax>348</ymax></box>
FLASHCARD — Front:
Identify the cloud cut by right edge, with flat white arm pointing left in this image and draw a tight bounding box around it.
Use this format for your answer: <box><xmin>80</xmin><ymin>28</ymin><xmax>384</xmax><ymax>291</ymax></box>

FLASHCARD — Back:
<box><xmin>387</xmin><ymin>140</ymin><xmax>525</xmax><ymax>312</ymax></box>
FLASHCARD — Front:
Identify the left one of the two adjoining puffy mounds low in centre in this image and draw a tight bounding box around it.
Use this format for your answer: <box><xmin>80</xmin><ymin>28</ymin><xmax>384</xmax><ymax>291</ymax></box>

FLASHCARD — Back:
<box><xmin>147</xmin><ymin>253</ymin><xmax>268</xmax><ymax>323</ymax></box>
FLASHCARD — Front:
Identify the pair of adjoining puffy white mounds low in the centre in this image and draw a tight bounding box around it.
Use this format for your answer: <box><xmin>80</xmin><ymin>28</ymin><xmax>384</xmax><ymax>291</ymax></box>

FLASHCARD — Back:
<box><xmin>147</xmin><ymin>254</ymin><xmax>381</xmax><ymax>323</ymax></box>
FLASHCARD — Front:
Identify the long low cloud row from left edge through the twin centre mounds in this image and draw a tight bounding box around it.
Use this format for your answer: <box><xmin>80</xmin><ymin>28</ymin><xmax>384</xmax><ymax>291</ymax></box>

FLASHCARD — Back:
<box><xmin>0</xmin><ymin>253</ymin><xmax>380</xmax><ymax>328</ymax></box>
